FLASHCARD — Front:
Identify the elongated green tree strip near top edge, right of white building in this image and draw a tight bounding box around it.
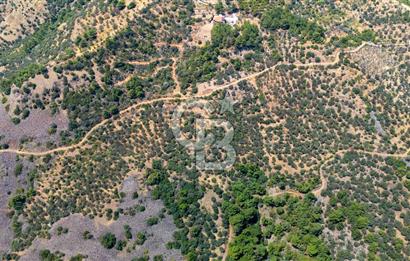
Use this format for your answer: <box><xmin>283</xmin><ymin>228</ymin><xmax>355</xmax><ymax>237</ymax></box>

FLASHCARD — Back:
<box><xmin>261</xmin><ymin>7</ymin><xmax>324</xmax><ymax>43</ymax></box>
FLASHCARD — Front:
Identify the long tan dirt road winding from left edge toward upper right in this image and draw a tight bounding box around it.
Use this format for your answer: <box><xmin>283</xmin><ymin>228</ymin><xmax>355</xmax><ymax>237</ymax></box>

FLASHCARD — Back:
<box><xmin>0</xmin><ymin>42</ymin><xmax>404</xmax><ymax>156</ymax></box>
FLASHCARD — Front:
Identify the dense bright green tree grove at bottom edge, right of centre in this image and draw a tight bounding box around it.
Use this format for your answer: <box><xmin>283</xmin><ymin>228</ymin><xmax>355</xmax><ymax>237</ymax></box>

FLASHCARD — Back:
<box><xmin>222</xmin><ymin>164</ymin><xmax>331</xmax><ymax>260</ymax></box>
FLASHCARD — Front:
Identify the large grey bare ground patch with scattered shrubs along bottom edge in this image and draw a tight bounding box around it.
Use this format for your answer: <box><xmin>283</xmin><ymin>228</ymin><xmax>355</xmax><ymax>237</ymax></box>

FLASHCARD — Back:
<box><xmin>20</xmin><ymin>177</ymin><xmax>183</xmax><ymax>261</ymax></box>
